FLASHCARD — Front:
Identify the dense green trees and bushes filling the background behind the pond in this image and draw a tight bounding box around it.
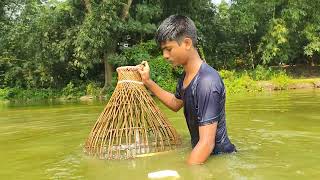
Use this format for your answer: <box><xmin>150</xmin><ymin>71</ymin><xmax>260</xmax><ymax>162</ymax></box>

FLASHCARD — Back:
<box><xmin>0</xmin><ymin>0</ymin><xmax>320</xmax><ymax>99</ymax></box>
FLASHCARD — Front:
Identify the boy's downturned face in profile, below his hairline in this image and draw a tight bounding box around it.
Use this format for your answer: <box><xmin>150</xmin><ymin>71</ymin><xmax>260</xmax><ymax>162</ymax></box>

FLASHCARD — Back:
<box><xmin>161</xmin><ymin>38</ymin><xmax>192</xmax><ymax>66</ymax></box>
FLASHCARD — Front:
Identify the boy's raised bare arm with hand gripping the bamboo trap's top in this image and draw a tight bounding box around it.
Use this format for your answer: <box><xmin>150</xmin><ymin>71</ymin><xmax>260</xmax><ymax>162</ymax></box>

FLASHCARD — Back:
<box><xmin>139</xmin><ymin>61</ymin><xmax>183</xmax><ymax>112</ymax></box>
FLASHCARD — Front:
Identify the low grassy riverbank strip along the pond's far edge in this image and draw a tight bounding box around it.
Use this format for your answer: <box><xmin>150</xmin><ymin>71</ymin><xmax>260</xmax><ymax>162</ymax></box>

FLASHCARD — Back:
<box><xmin>0</xmin><ymin>76</ymin><xmax>320</xmax><ymax>103</ymax></box>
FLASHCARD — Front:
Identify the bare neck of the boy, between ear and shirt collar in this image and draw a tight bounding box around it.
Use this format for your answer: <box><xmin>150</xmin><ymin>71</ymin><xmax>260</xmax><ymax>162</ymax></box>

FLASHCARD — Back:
<box><xmin>183</xmin><ymin>52</ymin><xmax>203</xmax><ymax>76</ymax></box>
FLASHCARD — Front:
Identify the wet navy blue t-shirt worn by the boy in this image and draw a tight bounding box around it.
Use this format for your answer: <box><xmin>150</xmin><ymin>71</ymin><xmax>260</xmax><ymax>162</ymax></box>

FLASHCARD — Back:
<box><xmin>175</xmin><ymin>62</ymin><xmax>236</xmax><ymax>154</ymax></box>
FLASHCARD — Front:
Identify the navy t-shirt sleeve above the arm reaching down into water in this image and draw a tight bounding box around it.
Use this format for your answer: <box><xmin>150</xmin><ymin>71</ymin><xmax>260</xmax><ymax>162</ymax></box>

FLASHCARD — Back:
<box><xmin>196</xmin><ymin>80</ymin><xmax>224</xmax><ymax>126</ymax></box>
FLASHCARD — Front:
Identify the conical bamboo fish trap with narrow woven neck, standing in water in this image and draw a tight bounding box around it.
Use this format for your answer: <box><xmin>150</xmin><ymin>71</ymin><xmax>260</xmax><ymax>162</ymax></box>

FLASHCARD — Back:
<box><xmin>85</xmin><ymin>66</ymin><xmax>180</xmax><ymax>159</ymax></box>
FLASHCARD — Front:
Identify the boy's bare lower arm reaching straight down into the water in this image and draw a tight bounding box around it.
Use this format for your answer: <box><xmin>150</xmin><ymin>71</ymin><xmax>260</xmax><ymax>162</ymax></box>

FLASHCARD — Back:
<box><xmin>187</xmin><ymin>122</ymin><xmax>217</xmax><ymax>165</ymax></box>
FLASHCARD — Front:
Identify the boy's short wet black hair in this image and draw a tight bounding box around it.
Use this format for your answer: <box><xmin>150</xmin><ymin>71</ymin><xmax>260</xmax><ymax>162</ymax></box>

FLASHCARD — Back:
<box><xmin>156</xmin><ymin>15</ymin><xmax>198</xmax><ymax>47</ymax></box>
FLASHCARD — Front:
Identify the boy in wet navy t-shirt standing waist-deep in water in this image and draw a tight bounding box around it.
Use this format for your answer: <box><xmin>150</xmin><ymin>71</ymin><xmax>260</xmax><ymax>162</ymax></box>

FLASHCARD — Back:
<box><xmin>139</xmin><ymin>15</ymin><xmax>236</xmax><ymax>164</ymax></box>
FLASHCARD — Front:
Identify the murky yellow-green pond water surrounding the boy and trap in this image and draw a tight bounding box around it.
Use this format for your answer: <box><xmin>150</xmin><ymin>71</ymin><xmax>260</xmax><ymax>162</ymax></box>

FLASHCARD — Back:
<box><xmin>0</xmin><ymin>90</ymin><xmax>320</xmax><ymax>179</ymax></box>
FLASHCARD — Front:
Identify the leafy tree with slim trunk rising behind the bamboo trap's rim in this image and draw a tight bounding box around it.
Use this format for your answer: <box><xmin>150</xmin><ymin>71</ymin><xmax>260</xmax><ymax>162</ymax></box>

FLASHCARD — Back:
<box><xmin>75</xmin><ymin>0</ymin><xmax>159</xmax><ymax>94</ymax></box>
